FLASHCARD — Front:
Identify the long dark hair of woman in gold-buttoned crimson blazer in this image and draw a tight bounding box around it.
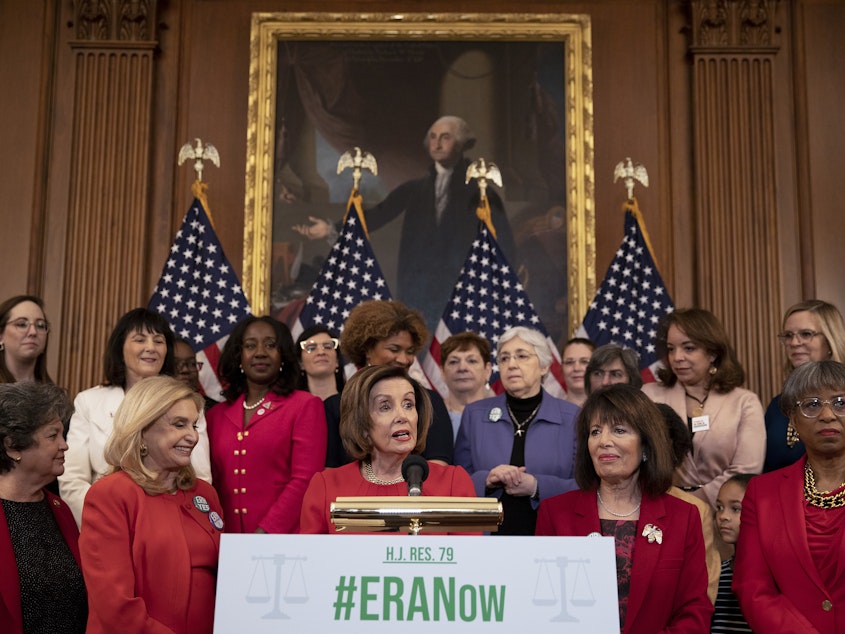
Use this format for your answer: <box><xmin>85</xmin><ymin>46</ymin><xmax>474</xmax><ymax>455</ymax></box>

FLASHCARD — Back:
<box><xmin>217</xmin><ymin>315</ymin><xmax>299</xmax><ymax>402</ymax></box>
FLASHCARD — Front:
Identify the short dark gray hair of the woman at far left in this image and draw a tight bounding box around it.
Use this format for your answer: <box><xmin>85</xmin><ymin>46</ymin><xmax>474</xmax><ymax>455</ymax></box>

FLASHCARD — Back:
<box><xmin>0</xmin><ymin>381</ymin><xmax>73</xmax><ymax>473</ymax></box>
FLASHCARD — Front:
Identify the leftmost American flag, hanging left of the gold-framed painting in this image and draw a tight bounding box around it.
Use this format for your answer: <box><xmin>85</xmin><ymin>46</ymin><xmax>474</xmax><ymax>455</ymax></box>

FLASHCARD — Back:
<box><xmin>149</xmin><ymin>198</ymin><xmax>252</xmax><ymax>400</ymax></box>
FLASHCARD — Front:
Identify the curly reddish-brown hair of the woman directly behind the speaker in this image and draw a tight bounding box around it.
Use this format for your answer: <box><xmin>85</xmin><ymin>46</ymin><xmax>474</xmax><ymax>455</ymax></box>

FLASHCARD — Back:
<box><xmin>340</xmin><ymin>300</ymin><xmax>428</xmax><ymax>368</ymax></box>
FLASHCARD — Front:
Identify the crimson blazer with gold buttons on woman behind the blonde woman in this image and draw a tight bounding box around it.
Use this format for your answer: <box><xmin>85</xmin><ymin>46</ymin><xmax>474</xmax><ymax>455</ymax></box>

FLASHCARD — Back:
<box><xmin>205</xmin><ymin>390</ymin><xmax>328</xmax><ymax>533</ymax></box>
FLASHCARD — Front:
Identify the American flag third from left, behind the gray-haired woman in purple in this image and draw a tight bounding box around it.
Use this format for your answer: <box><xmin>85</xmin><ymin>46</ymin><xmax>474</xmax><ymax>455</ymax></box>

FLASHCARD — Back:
<box><xmin>423</xmin><ymin>222</ymin><xmax>566</xmax><ymax>397</ymax></box>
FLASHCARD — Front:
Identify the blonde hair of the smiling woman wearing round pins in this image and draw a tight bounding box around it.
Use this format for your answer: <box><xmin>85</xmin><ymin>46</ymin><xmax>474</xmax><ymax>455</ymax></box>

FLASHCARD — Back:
<box><xmin>105</xmin><ymin>375</ymin><xmax>203</xmax><ymax>495</ymax></box>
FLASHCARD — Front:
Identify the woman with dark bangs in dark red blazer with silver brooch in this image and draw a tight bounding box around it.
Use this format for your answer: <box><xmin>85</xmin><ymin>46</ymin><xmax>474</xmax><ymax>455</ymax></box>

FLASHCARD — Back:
<box><xmin>537</xmin><ymin>384</ymin><xmax>713</xmax><ymax>634</ymax></box>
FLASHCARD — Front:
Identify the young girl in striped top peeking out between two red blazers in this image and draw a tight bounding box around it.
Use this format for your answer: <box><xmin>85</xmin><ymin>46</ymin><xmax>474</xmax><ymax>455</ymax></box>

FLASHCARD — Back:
<box><xmin>710</xmin><ymin>473</ymin><xmax>752</xmax><ymax>634</ymax></box>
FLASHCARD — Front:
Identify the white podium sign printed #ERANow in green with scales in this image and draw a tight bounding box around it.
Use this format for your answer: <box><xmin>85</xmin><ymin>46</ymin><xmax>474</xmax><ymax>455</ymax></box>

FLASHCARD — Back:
<box><xmin>214</xmin><ymin>534</ymin><xmax>619</xmax><ymax>634</ymax></box>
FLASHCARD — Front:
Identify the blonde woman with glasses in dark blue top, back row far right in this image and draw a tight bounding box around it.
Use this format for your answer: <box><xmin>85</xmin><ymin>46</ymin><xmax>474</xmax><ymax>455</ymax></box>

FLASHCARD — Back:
<box><xmin>763</xmin><ymin>299</ymin><xmax>845</xmax><ymax>472</ymax></box>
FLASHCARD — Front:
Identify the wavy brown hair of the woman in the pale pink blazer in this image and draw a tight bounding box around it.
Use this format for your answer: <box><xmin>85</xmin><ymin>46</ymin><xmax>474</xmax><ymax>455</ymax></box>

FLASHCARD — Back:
<box><xmin>657</xmin><ymin>308</ymin><xmax>745</xmax><ymax>394</ymax></box>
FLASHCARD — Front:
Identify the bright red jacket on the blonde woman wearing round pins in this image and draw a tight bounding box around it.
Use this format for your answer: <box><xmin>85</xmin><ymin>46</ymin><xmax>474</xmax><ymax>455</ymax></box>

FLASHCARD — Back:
<box><xmin>79</xmin><ymin>471</ymin><xmax>222</xmax><ymax>634</ymax></box>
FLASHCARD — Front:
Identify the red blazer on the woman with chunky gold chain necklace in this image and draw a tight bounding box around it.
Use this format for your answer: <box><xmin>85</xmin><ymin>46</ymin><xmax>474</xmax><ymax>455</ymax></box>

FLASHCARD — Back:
<box><xmin>733</xmin><ymin>456</ymin><xmax>845</xmax><ymax>634</ymax></box>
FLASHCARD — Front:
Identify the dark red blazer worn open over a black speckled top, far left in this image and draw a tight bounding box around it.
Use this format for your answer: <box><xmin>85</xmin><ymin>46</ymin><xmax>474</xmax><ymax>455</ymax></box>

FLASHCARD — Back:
<box><xmin>0</xmin><ymin>490</ymin><xmax>79</xmax><ymax>634</ymax></box>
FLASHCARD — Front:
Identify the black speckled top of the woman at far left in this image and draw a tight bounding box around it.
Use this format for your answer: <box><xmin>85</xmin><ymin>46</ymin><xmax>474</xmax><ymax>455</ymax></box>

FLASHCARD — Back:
<box><xmin>0</xmin><ymin>498</ymin><xmax>88</xmax><ymax>634</ymax></box>
